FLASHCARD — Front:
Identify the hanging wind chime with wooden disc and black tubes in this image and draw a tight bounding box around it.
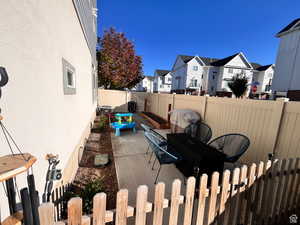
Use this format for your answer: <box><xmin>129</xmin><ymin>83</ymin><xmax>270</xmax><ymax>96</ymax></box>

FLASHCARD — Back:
<box><xmin>0</xmin><ymin>67</ymin><xmax>40</xmax><ymax>225</ymax></box>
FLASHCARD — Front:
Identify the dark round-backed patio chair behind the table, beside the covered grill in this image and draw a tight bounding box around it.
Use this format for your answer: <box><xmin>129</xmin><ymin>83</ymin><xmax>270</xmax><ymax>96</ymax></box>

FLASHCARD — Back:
<box><xmin>184</xmin><ymin>122</ymin><xmax>212</xmax><ymax>144</ymax></box>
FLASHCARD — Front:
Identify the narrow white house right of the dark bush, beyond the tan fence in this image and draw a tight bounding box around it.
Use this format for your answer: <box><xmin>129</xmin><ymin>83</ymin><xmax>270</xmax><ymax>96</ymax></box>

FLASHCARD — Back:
<box><xmin>251</xmin><ymin>63</ymin><xmax>275</xmax><ymax>94</ymax></box>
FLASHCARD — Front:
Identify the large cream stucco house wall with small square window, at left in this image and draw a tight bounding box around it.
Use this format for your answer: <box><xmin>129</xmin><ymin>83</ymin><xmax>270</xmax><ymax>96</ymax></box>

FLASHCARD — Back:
<box><xmin>0</xmin><ymin>0</ymin><xmax>97</xmax><ymax>219</ymax></box>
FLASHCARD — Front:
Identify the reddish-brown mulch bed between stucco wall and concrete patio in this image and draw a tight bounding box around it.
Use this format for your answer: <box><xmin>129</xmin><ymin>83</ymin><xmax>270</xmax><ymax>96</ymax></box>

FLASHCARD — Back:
<box><xmin>74</xmin><ymin>115</ymin><xmax>119</xmax><ymax>209</ymax></box>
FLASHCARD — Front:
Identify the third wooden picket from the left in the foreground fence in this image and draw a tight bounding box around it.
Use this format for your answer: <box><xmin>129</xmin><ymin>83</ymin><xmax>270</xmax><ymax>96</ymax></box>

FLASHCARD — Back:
<box><xmin>93</xmin><ymin>193</ymin><xmax>106</xmax><ymax>225</ymax></box>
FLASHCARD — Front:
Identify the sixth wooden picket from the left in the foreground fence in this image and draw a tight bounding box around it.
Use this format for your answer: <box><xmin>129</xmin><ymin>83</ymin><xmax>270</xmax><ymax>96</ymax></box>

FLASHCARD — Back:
<box><xmin>153</xmin><ymin>183</ymin><xmax>165</xmax><ymax>225</ymax></box>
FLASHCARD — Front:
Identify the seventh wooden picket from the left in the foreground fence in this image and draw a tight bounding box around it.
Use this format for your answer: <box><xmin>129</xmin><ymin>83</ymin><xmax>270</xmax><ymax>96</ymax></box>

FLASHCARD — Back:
<box><xmin>169</xmin><ymin>179</ymin><xmax>181</xmax><ymax>225</ymax></box>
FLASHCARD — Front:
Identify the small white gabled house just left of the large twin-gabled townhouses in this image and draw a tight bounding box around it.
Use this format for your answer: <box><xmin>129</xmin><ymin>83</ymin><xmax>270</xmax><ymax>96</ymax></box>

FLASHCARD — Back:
<box><xmin>153</xmin><ymin>70</ymin><xmax>172</xmax><ymax>93</ymax></box>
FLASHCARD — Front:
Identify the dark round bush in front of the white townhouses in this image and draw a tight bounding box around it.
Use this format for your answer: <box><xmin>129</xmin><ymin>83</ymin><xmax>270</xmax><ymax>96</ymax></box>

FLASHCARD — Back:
<box><xmin>228</xmin><ymin>73</ymin><xmax>248</xmax><ymax>98</ymax></box>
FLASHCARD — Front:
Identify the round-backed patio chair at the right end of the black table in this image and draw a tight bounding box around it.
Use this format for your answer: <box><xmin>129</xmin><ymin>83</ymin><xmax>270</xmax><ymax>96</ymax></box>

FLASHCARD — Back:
<box><xmin>208</xmin><ymin>134</ymin><xmax>250</xmax><ymax>163</ymax></box>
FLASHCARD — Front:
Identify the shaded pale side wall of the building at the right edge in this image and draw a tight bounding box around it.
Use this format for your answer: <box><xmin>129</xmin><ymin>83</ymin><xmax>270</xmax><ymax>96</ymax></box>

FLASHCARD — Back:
<box><xmin>272</xmin><ymin>30</ymin><xmax>300</xmax><ymax>91</ymax></box>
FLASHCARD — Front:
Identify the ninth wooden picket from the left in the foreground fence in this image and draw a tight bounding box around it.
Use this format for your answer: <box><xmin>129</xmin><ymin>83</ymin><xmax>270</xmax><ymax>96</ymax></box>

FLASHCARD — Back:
<box><xmin>196</xmin><ymin>174</ymin><xmax>207</xmax><ymax>225</ymax></box>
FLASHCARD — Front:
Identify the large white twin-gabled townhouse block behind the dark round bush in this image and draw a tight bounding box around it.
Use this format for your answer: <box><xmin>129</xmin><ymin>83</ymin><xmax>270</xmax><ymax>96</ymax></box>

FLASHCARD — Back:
<box><xmin>172</xmin><ymin>52</ymin><xmax>253</xmax><ymax>96</ymax></box>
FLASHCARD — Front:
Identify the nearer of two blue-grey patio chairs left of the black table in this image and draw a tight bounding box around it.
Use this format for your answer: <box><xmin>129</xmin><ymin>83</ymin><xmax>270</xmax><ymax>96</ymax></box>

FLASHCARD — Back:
<box><xmin>145</xmin><ymin>131</ymin><xmax>181</xmax><ymax>184</ymax></box>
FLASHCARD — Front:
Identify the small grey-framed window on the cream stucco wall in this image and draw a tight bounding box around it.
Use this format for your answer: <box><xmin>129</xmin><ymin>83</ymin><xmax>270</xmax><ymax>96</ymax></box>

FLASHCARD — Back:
<box><xmin>62</xmin><ymin>58</ymin><xmax>76</xmax><ymax>95</ymax></box>
